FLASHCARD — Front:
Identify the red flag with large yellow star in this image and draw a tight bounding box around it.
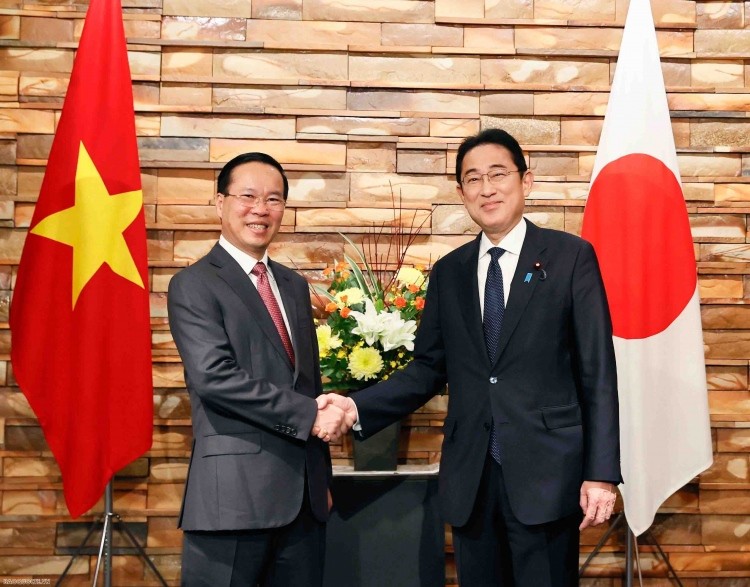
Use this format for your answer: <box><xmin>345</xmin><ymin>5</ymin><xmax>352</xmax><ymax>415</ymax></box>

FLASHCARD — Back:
<box><xmin>10</xmin><ymin>0</ymin><xmax>153</xmax><ymax>518</ymax></box>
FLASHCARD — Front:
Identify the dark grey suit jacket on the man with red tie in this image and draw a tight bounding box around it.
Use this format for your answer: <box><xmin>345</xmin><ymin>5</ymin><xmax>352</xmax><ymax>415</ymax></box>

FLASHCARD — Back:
<box><xmin>168</xmin><ymin>244</ymin><xmax>331</xmax><ymax>530</ymax></box>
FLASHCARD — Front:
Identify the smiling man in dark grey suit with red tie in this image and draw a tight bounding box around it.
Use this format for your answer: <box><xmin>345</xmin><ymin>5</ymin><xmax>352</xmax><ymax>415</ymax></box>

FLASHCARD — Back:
<box><xmin>168</xmin><ymin>153</ymin><xmax>347</xmax><ymax>587</ymax></box>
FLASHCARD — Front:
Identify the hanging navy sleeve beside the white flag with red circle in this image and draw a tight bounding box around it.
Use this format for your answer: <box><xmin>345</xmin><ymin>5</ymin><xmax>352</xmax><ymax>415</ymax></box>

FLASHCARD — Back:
<box><xmin>572</xmin><ymin>241</ymin><xmax>622</xmax><ymax>484</ymax></box>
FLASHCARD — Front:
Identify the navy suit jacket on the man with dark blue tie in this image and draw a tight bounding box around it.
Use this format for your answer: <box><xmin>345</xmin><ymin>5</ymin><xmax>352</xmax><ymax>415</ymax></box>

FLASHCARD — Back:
<box><xmin>352</xmin><ymin>221</ymin><xmax>621</xmax><ymax>526</ymax></box>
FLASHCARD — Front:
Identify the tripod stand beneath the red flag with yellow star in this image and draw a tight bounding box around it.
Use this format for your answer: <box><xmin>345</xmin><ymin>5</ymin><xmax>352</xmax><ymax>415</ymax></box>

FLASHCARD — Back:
<box><xmin>55</xmin><ymin>479</ymin><xmax>167</xmax><ymax>587</ymax></box>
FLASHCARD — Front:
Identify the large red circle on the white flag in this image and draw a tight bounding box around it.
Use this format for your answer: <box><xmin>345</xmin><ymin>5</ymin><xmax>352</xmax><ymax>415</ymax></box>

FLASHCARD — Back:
<box><xmin>581</xmin><ymin>153</ymin><xmax>697</xmax><ymax>339</ymax></box>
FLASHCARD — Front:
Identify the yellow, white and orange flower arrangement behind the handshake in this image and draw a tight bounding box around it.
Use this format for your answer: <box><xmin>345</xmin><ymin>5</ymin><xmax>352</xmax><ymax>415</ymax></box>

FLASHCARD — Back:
<box><xmin>315</xmin><ymin>235</ymin><xmax>427</xmax><ymax>391</ymax></box>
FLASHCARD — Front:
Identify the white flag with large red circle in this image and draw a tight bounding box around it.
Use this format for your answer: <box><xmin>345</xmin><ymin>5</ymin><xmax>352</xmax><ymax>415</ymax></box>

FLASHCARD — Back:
<box><xmin>582</xmin><ymin>0</ymin><xmax>713</xmax><ymax>536</ymax></box>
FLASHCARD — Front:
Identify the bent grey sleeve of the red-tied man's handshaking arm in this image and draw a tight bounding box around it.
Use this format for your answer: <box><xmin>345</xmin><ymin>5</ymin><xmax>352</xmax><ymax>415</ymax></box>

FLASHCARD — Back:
<box><xmin>167</xmin><ymin>272</ymin><xmax>317</xmax><ymax>441</ymax></box>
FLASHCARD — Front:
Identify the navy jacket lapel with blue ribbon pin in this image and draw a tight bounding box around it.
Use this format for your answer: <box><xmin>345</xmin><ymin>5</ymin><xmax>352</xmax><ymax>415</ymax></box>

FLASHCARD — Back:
<box><xmin>495</xmin><ymin>220</ymin><xmax>547</xmax><ymax>363</ymax></box>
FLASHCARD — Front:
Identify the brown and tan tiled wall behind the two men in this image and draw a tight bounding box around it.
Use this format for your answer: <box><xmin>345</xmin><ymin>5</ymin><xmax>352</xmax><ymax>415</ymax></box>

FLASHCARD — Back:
<box><xmin>0</xmin><ymin>0</ymin><xmax>750</xmax><ymax>587</ymax></box>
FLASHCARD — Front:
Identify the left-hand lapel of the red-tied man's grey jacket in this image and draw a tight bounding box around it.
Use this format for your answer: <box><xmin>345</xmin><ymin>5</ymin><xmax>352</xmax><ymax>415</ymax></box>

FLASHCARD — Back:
<box><xmin>209</xmin><ymin>244</ymin><xmax>294</xmax><ymax>369</ymax></box>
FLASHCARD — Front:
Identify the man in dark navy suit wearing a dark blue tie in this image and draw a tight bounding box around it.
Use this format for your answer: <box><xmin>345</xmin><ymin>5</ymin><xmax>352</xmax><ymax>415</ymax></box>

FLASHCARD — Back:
<box><xmin>329</xmin><ymin>129</ymin><xmax>621</xmax><ymax>587</ymax></box>
